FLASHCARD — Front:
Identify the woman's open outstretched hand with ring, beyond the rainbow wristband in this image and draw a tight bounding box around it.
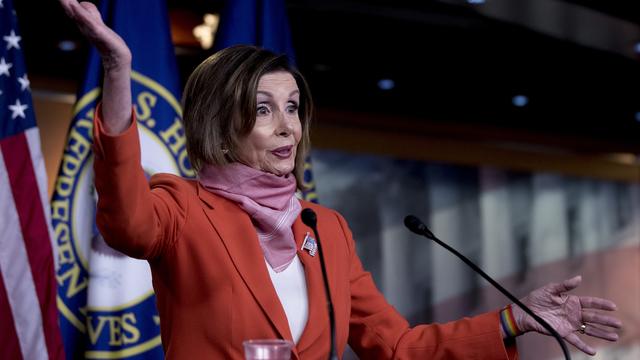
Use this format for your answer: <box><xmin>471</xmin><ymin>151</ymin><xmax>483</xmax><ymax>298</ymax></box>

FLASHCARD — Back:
<box><xmin>512</xmin><ymin>276</ymin><xmax>622</xmax><ymax>355</ymax></box>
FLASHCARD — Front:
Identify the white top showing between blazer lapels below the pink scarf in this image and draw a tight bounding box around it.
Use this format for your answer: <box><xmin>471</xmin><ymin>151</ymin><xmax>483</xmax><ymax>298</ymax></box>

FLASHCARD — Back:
<box><xmin>265</xmin><ymin>255</ymin><xmax>309</xmax><ymax>343</ymax></box>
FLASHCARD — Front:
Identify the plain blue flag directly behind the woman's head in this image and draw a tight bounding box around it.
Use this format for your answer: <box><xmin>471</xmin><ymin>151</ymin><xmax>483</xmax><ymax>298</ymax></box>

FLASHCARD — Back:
<box><xmin>214</xmin><ymin>0</ymin><xmax>318</xmax><ymax>202</ymax></box>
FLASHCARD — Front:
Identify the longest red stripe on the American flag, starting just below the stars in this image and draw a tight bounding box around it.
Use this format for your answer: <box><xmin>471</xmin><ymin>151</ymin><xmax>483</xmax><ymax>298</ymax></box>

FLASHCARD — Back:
<box><xmin>1</xmin><ymin>133</ymin><xmax>63</xmax><ymax>359</ymax></box>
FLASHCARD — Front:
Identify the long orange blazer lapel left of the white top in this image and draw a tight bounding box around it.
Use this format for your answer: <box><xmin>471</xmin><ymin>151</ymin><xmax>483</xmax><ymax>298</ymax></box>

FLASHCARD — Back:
<box><xmin>198</xmin><ymin>184</ymin><xmax>291</xmax><ymax>340</ymax></box>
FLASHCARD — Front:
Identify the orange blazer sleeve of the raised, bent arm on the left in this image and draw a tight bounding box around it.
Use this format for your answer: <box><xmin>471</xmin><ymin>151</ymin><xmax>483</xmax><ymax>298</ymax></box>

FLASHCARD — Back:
<box><xmin>93</xmin><ymin>105</ymin><xmax>189</xmax><ymax>259</ymax></box>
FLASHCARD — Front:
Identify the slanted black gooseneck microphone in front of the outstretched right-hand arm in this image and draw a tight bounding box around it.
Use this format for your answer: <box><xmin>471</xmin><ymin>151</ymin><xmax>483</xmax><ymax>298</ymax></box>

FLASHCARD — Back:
<box><xmin>404</xmin><ymin>215</ymin><xmax>571</xmax><ymax>360</ymax></box>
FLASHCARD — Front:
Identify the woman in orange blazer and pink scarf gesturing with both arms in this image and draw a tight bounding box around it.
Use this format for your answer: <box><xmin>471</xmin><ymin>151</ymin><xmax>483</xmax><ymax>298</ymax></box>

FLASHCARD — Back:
<box><xmin>60</xmin><ymin>0</ymin><xmax>620</xmax><ymax>359</ymax></box>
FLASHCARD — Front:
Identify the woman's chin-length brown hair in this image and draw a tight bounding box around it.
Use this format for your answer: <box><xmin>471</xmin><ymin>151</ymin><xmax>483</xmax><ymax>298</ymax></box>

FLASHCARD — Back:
<box><xmin>182</xmin><ymin>45</ymin><xmax>313</xmax><ymax>189</ymax></box>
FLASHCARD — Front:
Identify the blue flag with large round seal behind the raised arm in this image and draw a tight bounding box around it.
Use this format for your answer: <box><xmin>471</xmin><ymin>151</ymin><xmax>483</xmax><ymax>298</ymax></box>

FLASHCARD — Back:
<box><xmin>51</xmin><ymin>0</ymin><xmax>194</xmax><ymax>359</ymax></box>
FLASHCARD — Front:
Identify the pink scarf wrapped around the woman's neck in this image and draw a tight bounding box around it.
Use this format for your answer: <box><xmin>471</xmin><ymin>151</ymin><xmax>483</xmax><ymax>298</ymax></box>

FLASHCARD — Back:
<box><xmin>198</xmin><ymin>163</ymin><xmax>302</xmax><ymax>272</ymax></box>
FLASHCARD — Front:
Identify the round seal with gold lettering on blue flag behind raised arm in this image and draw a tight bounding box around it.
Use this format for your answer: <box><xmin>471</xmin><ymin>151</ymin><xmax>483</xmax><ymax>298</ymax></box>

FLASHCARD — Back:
<box><xmin>51</xmin><ymin>71</ymin><xmax>194</xmax><ymax>359</ymax></box>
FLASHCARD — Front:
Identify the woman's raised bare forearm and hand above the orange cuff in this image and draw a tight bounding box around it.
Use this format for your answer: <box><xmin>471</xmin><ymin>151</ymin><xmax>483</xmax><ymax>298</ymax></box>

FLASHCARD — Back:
<box><xmin>59</xmin><ymin>0</ymin><xmax>131</xmax><ymax>134</ymax></box>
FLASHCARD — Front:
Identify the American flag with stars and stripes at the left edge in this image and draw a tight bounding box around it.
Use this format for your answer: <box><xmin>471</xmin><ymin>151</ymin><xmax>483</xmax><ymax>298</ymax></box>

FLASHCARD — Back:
<box><xmin>0</xmin><ymin>0</ymin><xmax>64</xmax><ymax>359</ymax></box>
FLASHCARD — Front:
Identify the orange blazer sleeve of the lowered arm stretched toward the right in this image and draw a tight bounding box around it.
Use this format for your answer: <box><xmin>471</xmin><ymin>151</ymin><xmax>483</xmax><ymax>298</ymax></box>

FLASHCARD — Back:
<box><xmin>338</xmin><ymin>214</ymin><xmax>518</xmax><ymax>360</ymax></box>
